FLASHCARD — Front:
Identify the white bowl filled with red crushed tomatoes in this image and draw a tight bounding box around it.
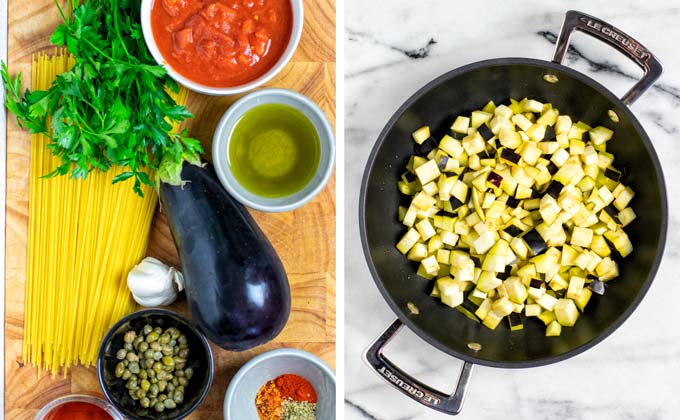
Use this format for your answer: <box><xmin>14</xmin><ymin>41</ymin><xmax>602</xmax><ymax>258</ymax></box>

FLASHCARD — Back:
<box><xmin>141</xmin><ymin>0</ymin><xmax>303</xmax><ymax>95</ymax></box>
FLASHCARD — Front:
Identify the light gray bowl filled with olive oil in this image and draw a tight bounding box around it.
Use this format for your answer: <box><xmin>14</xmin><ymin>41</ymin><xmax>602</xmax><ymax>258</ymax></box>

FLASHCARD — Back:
<box><xmin>212</xmin><ymin>89</ymin><xmax>335</xmax><ymax>212</ymax></box>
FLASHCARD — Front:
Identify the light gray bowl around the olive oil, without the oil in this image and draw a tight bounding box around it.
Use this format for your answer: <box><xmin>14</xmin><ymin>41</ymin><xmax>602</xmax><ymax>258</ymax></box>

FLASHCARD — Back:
<box><xmin>212</xmin><ymin>89</ymin><xmax>335</xmax><ymax>212</ymax></box>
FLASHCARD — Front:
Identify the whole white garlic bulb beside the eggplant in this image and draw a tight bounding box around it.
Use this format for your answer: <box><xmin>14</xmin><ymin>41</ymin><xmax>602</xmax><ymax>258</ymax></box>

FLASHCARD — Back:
<box><xmin>128</xmin><ymin>257</ymin><xmax>184</xmax><ymax>306</ymax></box>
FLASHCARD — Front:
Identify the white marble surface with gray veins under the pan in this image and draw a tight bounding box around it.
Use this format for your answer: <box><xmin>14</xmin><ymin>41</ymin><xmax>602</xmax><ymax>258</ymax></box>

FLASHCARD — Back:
<box><xmin>345</xmin><ymin>0</ymin><xmax>680</xmax><ymax>420</ymax></box>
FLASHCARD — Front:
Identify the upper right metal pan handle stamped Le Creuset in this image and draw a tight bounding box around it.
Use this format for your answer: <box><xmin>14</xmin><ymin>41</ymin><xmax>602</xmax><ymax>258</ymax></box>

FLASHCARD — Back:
<box><xmin>552</xmin><ymin>10</ymin><xmax>663</xmax><ymax>106</ymax></box>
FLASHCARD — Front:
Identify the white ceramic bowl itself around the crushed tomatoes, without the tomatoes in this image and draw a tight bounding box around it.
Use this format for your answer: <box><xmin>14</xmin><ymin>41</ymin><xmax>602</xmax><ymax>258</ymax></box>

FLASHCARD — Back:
<box><xmin>141</xmin><ymin>0</ymin><xmax>304</xmax><ymax>95</ymax></box>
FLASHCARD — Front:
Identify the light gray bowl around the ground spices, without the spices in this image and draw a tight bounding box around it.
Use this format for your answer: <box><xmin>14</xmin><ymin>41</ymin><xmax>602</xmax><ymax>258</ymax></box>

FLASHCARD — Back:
<box><xmin>224</xmin><ymin>349</ymin><xmax>335</xmax><ymax>420</ymax></box>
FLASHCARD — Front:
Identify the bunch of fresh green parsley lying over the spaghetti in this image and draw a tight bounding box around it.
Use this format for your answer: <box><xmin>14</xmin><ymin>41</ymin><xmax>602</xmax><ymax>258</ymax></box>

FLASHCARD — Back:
<box><xmin>0</xmin><ymin>0</ymin><xmax>203</xmax><ymax>195</ymax></box>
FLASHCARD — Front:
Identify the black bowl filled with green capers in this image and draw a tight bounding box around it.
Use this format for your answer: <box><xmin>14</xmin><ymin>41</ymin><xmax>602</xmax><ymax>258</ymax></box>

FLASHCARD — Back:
<box><xmin>97</xmin><ymin>309</ymin><xmax>213</xmax><ymax>420</ymax></box>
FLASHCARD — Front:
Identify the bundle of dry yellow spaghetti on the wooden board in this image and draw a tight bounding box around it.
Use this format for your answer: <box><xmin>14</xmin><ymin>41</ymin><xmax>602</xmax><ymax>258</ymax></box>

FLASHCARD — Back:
<box><xmin>23</xmin><ymin>51</ymin><xmax>187</xmax><ymax>375</ymax></box>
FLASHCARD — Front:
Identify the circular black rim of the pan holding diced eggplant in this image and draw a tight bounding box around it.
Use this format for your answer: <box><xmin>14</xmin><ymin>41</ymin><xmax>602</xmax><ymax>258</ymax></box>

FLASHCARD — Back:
<box><xmin>359</xmin><ymin>57</ymin><xmax>668</xmax><ymax>369</ymax></box>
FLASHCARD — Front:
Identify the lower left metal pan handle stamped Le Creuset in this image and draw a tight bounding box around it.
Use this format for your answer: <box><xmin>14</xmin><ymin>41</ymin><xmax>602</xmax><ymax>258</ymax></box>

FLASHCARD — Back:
<box><xmin>364</xmin><ymin>319</ymin><xmax>474</xmax><ymax>416</ymax></box>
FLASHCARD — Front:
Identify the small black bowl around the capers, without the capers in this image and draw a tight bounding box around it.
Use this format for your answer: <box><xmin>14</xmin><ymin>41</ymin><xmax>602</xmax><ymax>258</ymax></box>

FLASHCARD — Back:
<box><xmin>97</xmin><ymin>309</ymin><xmax>214</xmax><ymax>420</ymax></box>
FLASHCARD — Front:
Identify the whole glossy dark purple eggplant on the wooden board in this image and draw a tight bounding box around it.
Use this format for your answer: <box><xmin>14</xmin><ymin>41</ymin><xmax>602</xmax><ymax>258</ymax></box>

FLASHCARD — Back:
<box><xmin>160</xmin><ymin>163</ymin><xmax>290</xmax><ymax>351</ymax></box>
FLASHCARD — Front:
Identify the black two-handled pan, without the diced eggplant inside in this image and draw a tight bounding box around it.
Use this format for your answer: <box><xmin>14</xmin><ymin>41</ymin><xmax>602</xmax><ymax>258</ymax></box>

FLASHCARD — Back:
<box><xmin>359</xmin><ymin>11</ymin><xmax>667</xmax><ymax>414</ymax></box>
